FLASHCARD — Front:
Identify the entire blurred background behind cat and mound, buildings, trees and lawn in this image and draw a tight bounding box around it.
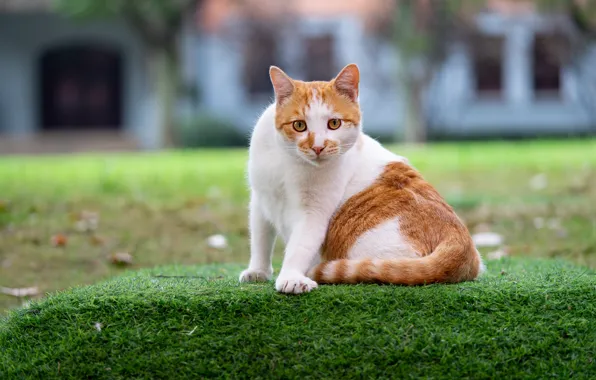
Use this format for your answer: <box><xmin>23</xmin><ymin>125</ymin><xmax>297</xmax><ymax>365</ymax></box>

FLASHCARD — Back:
<box><xmin>0</xmin><ymin>0</ymin><xmax>596</xmax><ymax>310</ymax></box>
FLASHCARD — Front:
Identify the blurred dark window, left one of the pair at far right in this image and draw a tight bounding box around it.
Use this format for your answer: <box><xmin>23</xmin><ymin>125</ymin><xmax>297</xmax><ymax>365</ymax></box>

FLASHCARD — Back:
<box><xmin>472</xmin><ymin>35</ymin><xmax>504</xmax><ymax>97</ymax></box>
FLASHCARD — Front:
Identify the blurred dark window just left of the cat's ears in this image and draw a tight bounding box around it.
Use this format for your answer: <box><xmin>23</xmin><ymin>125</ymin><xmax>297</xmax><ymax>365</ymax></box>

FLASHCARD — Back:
<box><xmin>244</xmin><ymin>25</ymin><xmax>279</xmax><ymax>95</ymax></box>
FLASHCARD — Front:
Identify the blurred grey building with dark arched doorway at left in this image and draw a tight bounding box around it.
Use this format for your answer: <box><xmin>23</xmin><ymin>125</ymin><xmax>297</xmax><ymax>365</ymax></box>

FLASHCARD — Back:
<box><xmin>0</xmin><ymin>0</ymin><xmax>159</xmax><ymax>153</ymax></box>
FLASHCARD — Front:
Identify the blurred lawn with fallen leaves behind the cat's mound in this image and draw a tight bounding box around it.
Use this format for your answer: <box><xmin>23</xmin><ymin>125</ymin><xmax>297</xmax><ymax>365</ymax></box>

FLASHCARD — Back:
<box><xmin>0</xmin><ymin>140</ymin><xmax>596</xmax><ymax>314</ymax></box>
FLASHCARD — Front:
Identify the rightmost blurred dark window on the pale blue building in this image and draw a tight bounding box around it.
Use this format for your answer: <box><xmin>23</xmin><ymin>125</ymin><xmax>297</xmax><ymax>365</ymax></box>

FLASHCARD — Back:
<box><xmin>532</xmin><ymin>35</ymin><xmax>566</xmax><ymax>96</ymax></box>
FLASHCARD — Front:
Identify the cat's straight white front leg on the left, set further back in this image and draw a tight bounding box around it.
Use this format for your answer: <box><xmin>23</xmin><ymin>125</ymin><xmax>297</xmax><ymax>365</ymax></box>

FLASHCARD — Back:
<box><xmin>240</xmin><ymin>195</ymin><xmax>275</xmax><ymax>282</ymax></box>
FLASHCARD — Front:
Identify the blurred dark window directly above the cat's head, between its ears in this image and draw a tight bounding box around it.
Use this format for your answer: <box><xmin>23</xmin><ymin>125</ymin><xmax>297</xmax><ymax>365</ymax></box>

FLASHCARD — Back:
<box><xmin>304</xmin><ymin>35</ymin><xmax>337</xmax><ymax>81</ymax></box>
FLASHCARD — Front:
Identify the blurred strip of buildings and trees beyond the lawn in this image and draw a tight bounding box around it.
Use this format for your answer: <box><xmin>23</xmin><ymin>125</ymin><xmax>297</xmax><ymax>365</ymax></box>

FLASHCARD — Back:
<box><xmin>0</xmin><ymin>0</ymin><xmax>596</xmax><ymax>152</ymax></box>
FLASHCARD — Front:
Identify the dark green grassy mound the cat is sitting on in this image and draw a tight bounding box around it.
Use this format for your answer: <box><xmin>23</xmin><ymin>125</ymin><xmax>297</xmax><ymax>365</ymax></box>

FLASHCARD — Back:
<box><xmin>0</xmin><ymin>259</ymin><xmax>596</xmax><ymax>379</ymax></box>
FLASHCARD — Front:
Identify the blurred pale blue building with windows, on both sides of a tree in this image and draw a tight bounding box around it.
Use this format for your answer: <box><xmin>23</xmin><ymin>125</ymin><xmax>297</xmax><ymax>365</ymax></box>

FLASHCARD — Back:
<box><xmin>198</xmin><ymin>0</ymin><xmax>596</xmax><ymax>138</ymax></box>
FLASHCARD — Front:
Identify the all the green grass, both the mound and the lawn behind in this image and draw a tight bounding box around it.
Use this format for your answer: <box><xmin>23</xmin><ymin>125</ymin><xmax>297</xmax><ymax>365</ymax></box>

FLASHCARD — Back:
<box><xmin>0</xmin><ymin>140</ymin><xmax>596</xmax><ymax>379</ymax></box>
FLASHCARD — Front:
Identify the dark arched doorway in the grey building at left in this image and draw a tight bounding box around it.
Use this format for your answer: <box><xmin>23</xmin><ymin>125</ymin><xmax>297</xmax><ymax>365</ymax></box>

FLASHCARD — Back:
<box><xmin>40</xmin><ymin>45</ymin><xmax>122</xmax><ymax>130</ymax></box>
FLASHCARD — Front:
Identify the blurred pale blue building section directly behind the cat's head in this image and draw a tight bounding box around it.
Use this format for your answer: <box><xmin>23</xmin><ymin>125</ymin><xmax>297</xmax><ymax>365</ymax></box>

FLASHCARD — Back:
<box><xmin>197</xmin><ymin>0</ymin><xmax>401</xmax><ymax>141</ymax></box>
